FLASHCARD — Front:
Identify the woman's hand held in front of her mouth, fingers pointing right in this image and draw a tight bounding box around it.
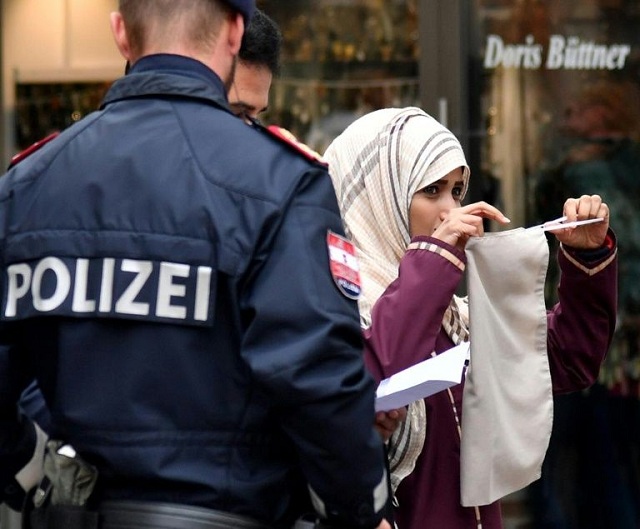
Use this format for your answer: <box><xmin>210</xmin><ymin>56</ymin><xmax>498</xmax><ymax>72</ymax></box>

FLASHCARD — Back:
<box><xmin>433</xmin><ymin>202</ymin><xmax>511</xmax><ymax>250</ymax></box>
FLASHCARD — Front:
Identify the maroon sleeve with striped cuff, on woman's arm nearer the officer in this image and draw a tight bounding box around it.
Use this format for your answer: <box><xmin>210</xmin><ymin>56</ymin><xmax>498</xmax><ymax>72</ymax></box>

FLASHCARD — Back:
<box><xmin>364</xmin><ymin>237</ymin><xmax>466</xmax><ymax>381</ymax></box>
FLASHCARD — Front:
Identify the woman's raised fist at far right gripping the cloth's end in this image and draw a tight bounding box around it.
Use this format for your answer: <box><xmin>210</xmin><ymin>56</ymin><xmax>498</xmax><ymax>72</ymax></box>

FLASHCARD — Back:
<box><xmin>550</xmin><ymin>195</ymin><xmax>609</xmax><ymax>250</ymax></box>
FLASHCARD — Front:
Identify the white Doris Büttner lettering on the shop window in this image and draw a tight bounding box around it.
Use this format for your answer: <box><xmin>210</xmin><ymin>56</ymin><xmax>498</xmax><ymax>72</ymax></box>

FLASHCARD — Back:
<box><xmin>484</xmin><ymin>35</ymin><xmax>631</xmax><ymax>70</ymax></box>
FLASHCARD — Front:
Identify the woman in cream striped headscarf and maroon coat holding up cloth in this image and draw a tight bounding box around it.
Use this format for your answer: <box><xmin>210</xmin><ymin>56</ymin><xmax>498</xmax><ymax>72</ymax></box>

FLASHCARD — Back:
<box><xmin>325</xmin><ymin>107</ymin><xmax>616</xmax><ymax>529</ymax></box>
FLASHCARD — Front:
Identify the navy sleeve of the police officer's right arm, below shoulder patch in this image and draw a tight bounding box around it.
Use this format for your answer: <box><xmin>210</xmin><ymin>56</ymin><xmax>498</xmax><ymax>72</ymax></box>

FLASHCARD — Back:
<box><xmin>243</xmin><ymin>170</ymin><xmax>389</xmax><ymax>528</ymax></box>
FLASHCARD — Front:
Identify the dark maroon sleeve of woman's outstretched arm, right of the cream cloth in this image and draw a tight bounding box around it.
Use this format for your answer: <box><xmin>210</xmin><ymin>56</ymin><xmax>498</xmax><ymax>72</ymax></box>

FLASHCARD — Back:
<box><xmin>547</xmin><ymin>232</ymin><xmax>618</xmax><ymax>393</ymax></box>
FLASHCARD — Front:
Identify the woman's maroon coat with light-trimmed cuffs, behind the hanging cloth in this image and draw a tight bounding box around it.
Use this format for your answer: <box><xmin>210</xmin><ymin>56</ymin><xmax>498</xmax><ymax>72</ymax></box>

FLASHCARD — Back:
<box><xmin>364</xmin><ymin>234</ymin><xmax>617</xmax><ymax>529</ymax></box>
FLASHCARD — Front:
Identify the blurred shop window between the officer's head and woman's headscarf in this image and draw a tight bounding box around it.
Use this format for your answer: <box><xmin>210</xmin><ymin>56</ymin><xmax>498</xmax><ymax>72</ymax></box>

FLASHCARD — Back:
<box><xmin>258</xmin><ymin>0</ymin><xmax>419</xmax><ymax>152</ymax></box>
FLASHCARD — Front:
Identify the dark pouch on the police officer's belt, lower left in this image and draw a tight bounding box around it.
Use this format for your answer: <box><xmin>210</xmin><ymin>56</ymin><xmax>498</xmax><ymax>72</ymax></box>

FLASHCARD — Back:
<box><xmin>22</xmin><ymin>440</ymin><xmax>98</xmax><ymax>529</ymax></box>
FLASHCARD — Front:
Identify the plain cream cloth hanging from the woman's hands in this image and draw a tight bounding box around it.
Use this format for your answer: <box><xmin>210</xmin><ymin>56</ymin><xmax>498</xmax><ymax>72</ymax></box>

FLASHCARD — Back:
<box><xmin>461</xmin><ymin>228</ymin><xmax>553</xmax><ymax>507</ymax></box>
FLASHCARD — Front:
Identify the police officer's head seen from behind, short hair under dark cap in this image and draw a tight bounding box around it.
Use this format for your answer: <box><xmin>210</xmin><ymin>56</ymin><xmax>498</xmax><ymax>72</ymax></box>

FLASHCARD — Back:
<box><xmin>111</xmin><ymin>0</ymin><xmax>255</xmax><ymax>83</ymax></box>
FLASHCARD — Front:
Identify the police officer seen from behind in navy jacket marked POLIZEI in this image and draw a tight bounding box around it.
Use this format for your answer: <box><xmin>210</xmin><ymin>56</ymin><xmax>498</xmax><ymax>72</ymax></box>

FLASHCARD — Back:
<box><xmin>0</xmin><ymin>0</ymin><xmax>389</xmax><ymax>529</ymax></box>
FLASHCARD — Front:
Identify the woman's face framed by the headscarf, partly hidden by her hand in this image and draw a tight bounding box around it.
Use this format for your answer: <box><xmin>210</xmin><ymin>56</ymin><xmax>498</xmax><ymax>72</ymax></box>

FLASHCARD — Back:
<box><xmin>409</xmin><ymin>167</ymin><xmax>464</xmax><ymax>237</ymax></box>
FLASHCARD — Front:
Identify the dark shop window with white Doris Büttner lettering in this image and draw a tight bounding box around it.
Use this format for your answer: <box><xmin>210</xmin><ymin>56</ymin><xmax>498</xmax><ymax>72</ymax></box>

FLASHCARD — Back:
<box><xmin>469</xmin><ymin>4</ymin><xmax>640</xmax><ymax>529</ymax></box>
